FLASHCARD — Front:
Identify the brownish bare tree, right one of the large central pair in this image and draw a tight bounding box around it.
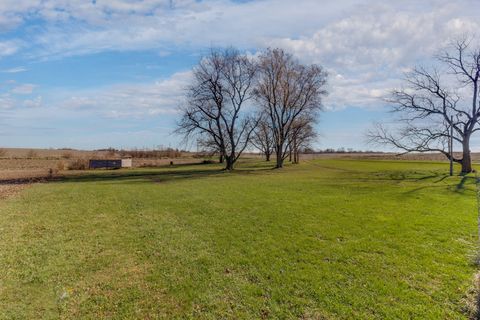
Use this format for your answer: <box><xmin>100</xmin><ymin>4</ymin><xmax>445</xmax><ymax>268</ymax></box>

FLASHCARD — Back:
<box><xmin>255</xmin><ymin>49</ymin><xmax>327</xmax><ymax>168</ymax></box>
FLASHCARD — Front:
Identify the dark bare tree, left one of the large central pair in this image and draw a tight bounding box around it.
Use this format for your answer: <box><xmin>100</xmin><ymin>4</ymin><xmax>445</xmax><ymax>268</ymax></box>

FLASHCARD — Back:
<box><xmin>176</xmin><ymin>48</ymin><xmax>258</xmax><ymax>170</ymax></box>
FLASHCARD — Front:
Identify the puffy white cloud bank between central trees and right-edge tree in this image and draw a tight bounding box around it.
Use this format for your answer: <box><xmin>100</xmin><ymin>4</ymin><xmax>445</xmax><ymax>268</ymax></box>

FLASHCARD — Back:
<box><xmin>269</xmin><ymin>1</ymin><xmax>480</xmax><ymax>109</ymax></box>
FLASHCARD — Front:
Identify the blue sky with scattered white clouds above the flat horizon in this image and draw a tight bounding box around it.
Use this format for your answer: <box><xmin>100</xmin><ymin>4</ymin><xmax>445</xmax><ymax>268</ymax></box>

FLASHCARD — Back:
<box><xmin>0</xmin><ymin>0</ymin><xmax>480</xmax><ymax>150</ymax></box>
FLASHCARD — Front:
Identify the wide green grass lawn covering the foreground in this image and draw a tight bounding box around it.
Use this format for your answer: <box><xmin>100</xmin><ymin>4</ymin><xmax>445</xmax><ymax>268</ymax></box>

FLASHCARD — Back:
<box><xmin>0</xmin><ymin>160</ymin><xmax>478</xmax><ymax>319</ymax></box>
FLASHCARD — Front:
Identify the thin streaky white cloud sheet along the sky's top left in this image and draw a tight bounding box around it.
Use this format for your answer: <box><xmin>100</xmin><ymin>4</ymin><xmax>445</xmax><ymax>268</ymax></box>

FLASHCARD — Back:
<box><xmin>0</xmin><ymin>0</ymin><xmax>360</xmax><ymax>58</ymax></box>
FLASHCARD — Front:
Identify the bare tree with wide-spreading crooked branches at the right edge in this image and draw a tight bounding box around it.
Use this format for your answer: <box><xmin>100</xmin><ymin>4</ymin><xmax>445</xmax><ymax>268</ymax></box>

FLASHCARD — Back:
<box><xmin>368</xmin><ymin>40</ymin><xmax>480</xmax><ymax>173</ymax></box>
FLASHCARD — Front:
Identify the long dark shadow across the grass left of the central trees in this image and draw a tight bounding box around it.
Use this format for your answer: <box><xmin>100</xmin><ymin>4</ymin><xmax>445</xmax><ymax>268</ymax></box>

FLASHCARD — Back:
<box><xmin>58</xmin><ymin>164</ymin><xmax>271</xmax><ymax>183</ymax></box>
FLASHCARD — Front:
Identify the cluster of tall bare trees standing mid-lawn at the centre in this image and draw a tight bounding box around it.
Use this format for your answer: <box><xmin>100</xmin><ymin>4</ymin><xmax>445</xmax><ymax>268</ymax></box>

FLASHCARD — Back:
<box><xmin>176</xmin><ymin>48</ymin><xmax>327</xmax><ymax>170</ymax></box>
